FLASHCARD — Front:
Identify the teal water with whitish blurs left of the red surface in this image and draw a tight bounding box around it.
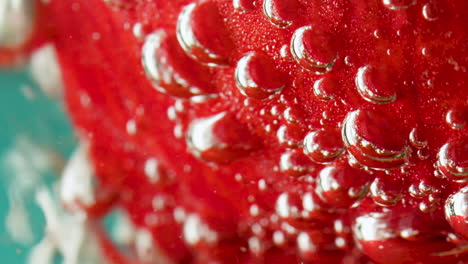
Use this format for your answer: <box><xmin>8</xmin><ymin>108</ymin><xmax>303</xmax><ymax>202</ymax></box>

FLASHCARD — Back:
<box><xmin>0</xmin><ymin>68</ymin><xmax>76</xmax><ymax>263</ymax></box>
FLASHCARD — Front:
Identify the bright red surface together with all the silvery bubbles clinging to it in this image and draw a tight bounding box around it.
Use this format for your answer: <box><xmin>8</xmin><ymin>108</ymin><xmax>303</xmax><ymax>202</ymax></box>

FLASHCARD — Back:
<box><xmin>0</xmin><ymin>0</ymin><xmax>468</xmax><ymax>263</ymax></box>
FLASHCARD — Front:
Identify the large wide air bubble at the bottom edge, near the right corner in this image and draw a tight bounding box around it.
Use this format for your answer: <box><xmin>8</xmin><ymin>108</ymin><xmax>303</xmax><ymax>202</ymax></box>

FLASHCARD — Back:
<box><xmin>353</xmin><ymin>208</ymin><xmax>456</xmax><ymax>263</ymax></box>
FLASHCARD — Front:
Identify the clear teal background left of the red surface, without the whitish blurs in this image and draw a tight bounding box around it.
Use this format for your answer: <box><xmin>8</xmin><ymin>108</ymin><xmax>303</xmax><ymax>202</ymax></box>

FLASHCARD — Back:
<box><xmin>0</xmin><ymin>69</ymin><xmax>76</xmax><ymax>264</ymax></box>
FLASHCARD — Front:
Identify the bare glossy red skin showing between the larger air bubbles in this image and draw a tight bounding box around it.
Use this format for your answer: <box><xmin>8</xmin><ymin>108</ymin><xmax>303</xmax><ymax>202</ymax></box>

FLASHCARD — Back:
<box><xmin>3</xmin><ymin>0</ymin><xmax>468</xmax><ymax>263</ymax></box>
